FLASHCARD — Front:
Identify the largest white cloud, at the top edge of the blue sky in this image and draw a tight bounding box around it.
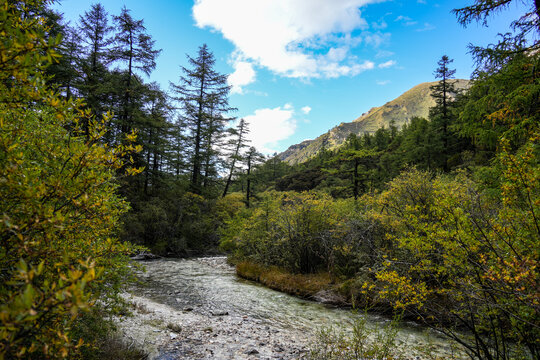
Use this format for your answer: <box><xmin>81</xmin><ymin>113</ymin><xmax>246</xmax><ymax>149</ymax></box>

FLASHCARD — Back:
<box><xmin>193</xmin><ymin>0</ymin><xmax>381</xmax><ymax>78</ymax></box>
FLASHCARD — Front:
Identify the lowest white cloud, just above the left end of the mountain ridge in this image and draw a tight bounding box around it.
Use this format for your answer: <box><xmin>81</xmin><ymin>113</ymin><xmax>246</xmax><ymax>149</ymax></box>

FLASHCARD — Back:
<box><xmin>244</xmin><ymin>104</ymin><xmax>297</xmax><ymax>154</ymax></box>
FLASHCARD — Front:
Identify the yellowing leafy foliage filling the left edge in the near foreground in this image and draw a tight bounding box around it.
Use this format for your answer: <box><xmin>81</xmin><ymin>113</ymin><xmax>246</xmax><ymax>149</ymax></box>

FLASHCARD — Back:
<box><xmin>0</xmin><ymin>1</ymin><xmax>137</xmax><ymax>359</ymax></box>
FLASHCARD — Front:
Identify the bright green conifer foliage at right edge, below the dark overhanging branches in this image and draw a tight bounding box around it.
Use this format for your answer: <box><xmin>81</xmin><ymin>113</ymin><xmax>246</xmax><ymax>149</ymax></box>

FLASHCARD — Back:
<box><xmin>454</xmin><ymin>54</ymin><xmax>540</xmax><ymax>154</ymax></box>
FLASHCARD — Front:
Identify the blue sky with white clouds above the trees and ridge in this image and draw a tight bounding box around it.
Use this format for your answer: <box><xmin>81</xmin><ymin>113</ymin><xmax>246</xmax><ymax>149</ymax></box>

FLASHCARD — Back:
<box><xmin>54</xmin><ymin>0</ymin><xmax>523</xmax><ymax>154</ymax></box>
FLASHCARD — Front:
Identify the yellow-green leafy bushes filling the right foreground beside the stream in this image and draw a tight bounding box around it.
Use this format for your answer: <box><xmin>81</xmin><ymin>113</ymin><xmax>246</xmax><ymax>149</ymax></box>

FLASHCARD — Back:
<box><xmin>364</xmin><ymin>165</ymin><xmax>540</xmax><ymax>359</ymax></box>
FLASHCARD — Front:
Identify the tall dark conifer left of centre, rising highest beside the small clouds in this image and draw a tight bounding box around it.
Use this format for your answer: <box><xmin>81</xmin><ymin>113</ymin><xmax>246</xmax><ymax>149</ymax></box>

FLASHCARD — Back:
<box><xmin>171</xmin><ymin>44</ymin><xmax>233</xmax><ymax>194</ymax></box>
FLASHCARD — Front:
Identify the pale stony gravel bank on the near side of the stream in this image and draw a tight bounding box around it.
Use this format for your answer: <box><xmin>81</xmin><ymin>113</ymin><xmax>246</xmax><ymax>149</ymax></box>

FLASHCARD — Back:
<box><xmin>116</xmin><ymin>294</ymin><xmax>312</xmax><ymax>360</ymax></box>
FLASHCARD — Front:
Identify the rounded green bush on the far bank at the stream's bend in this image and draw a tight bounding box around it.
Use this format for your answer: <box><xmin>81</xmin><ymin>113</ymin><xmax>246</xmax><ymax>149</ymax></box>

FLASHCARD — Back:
<box><xmin>221</xmin><ymin>192</ymin><xmax>375</xmax><ymax>276</ymax></box>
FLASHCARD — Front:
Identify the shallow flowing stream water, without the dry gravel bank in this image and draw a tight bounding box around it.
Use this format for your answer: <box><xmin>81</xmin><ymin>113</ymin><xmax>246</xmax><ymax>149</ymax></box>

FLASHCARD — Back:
<box><xmin>129</xmin><ymin>257</ymin><xmax>462</xmax><ymax>358</ymax></box>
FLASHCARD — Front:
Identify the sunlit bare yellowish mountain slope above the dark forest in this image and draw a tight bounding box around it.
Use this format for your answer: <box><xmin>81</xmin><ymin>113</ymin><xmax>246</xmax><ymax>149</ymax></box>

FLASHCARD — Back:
<box><xmin>278</xmin><ymin>79</ymin><xmax>469</xmax><ymax>164</ymax></box>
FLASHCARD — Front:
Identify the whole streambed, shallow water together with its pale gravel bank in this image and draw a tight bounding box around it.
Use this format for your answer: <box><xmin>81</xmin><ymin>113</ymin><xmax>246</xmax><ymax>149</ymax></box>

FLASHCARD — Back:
<box><xmin>119</xmin><ymin>257</ymin><xmax>464</xmax><ymax>360</ymax></box>
